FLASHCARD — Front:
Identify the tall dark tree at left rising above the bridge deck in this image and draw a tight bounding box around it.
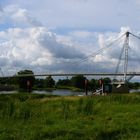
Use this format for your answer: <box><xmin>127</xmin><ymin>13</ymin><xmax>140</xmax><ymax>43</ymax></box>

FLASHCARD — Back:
<box><xmin>17</xmin><ymin>70</ymin><xmax>35</xmax><ymax>92</ymax></box>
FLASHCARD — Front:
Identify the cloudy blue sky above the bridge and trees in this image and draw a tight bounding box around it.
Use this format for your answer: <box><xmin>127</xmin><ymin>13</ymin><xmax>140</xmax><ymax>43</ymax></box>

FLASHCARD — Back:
<box><xmin>0</xmin><ymin>0</ymin><xmax>140</xmax><ymax>78</ymax></box>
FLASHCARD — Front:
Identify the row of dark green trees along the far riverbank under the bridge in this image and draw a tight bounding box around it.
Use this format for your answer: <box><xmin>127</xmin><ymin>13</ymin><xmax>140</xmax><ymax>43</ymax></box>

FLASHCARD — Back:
<box><xmin>0</xmin><ymin>70</ymin><xmax>140</xmax><ymax>91</ymax></box>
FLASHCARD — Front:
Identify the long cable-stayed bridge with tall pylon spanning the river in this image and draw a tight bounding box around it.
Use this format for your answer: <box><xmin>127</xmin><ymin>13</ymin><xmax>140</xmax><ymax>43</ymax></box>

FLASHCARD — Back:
<box><xmin>0</xmin><ymin>32</ymin><xmax>140</xmax><ymax>83</ymax></box>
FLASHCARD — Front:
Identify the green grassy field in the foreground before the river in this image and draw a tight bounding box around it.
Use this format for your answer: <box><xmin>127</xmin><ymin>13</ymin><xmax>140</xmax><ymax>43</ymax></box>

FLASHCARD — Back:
<box><xmin>0</xmin><ymin>93</ymin><xmax>140</xmax><ymax>140</ymax></box>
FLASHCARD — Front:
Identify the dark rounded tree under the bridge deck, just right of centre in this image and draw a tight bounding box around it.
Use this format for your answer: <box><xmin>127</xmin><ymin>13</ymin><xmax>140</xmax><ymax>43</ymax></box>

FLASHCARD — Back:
<box><xmin>71</xmin><ymin>75</ymin><xmax>86</xmax><ymax>89</ymax></box>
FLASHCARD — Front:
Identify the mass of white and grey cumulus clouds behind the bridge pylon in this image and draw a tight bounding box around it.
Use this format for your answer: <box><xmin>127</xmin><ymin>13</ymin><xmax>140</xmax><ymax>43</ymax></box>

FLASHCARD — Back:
<box><xmin>0</xmin><ymin>1</ymin><xmax>140</xmax><ymax>79</ymax></box>
